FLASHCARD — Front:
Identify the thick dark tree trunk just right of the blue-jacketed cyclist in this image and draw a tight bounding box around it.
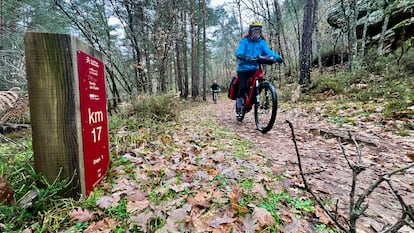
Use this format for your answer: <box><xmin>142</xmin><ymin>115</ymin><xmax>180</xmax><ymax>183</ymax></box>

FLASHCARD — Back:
<box><xmin>299</xmin><ymin>0</ymin><xmax>314</xmax><ymax>85</ymax></box>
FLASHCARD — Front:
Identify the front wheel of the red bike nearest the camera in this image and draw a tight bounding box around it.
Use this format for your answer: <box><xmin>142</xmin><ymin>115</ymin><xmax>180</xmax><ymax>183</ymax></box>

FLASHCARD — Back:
<box><xmin>254</xmin><ymin>81</ymin><xmax>277</xmax><ymax>134</ymax></box>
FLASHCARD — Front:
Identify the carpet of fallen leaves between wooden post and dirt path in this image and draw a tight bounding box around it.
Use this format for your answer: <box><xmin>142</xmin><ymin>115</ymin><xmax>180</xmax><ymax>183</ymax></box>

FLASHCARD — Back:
<box><xmin>71</xmin><ymin>104</ymin><xmax>312</xmax><ymax>232</ymax></box>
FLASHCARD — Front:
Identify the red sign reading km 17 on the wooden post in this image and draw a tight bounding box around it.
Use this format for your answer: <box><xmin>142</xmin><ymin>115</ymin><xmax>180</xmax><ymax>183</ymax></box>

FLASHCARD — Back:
<box><xmin>77</xmin><ymin>51</ymin><xmax>109</xmax><ymax>195</ymax></box>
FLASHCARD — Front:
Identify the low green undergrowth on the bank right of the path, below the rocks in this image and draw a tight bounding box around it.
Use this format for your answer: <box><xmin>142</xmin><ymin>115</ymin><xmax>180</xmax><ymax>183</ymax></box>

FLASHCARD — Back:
<box><xmin>282</xmin><ymin>42</ymin><xmax>414</xmax><ymax>135</ymax></box>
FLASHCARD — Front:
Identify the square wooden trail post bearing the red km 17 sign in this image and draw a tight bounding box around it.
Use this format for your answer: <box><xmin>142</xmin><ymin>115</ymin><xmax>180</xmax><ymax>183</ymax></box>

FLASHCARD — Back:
<box><xmin>24</xmin><ymin>32</ymin><xmax>109</xmax><ymax>198</ymax></box>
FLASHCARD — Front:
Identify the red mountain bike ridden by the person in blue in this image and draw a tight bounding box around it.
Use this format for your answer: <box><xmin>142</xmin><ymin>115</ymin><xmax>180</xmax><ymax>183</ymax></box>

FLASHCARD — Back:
<box><xmin>237</xmin><ymin>56</ymin><xmax>277</xmax><ymax>134</ymax></box>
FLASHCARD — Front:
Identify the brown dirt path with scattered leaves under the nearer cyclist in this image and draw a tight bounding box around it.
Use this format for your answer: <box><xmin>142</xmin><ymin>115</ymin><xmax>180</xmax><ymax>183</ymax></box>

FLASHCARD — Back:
<box><xmin>208</xmin><ymin>95</ymin><xmax>414</xmax><ymax>232</ymax></box>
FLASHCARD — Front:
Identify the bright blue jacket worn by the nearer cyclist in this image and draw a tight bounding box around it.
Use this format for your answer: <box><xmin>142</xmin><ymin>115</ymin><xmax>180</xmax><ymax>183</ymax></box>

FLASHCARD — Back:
<box><xmin>236</xmin><ymin>37</ymin><xmax>282</xmax><ymax>71</ymax></box>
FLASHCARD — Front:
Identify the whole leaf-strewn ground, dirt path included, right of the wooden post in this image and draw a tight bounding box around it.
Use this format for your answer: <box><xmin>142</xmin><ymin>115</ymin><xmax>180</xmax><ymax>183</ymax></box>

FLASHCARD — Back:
<box><xmin>0</xmin><ymin>94</ymin><xmax>414</xmax><ymax>233</ymax></box>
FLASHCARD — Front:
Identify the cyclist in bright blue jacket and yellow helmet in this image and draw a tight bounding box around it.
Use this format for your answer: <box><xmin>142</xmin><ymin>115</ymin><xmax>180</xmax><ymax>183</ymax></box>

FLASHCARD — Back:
<box><xmin>236</xmin><ymin>21</ymin><xmax>283</xmax><ymax>117</ymax></box>
